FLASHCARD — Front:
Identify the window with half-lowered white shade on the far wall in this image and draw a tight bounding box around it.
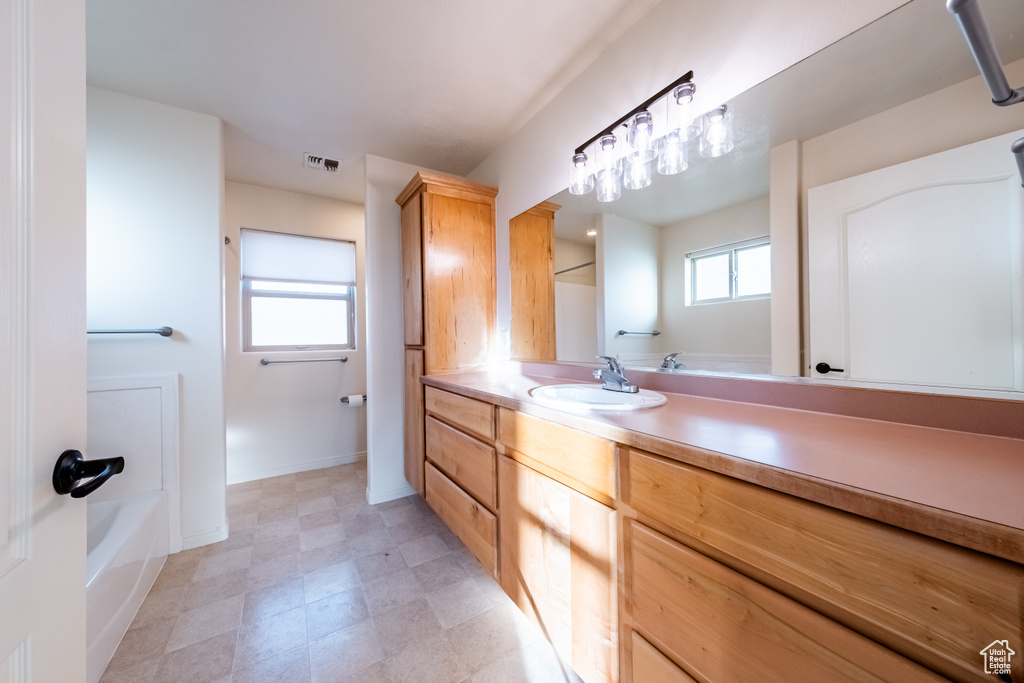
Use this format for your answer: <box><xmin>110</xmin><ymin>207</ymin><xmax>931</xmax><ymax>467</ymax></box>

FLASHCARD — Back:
<box><xmin>242</xmin><ymin>229</ymin><xmax>355</xmax><ymax>351</ymax></box>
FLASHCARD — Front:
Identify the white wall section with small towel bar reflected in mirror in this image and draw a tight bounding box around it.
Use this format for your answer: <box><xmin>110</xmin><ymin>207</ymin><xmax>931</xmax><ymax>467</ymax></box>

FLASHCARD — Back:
<box><xmin>597</xmin><ymin>214</ymin><xmax>662</xmax><ymax>364</ymax></box>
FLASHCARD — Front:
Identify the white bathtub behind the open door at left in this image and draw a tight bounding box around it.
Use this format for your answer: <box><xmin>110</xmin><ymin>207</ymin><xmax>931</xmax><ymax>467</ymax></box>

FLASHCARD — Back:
<box><xmin>85</xmin><ymin>490</ymin><xmax>168</xmax><ymax>683</ymax></box>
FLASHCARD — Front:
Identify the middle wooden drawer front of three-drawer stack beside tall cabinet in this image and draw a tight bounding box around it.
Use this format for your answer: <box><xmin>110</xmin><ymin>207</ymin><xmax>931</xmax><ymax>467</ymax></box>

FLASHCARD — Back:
<box><xmin>427</xmin><ymin>417</ymin><xmax>497</xmax><ymax>511</ymax></box>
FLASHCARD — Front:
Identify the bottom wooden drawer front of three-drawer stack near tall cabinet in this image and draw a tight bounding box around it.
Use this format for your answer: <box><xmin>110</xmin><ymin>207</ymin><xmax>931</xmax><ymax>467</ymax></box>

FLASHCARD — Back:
<box><xmin>425</xmin><ymin>463</ymin><xmax>498</xmax><ymax>575</ymax></box>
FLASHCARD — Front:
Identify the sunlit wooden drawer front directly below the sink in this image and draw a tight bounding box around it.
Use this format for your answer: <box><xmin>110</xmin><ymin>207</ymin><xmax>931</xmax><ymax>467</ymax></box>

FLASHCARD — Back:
<box><xmin>498</xmin><ymin>408</ymin><xmax>615</xmax><ymax>504</ymax></box>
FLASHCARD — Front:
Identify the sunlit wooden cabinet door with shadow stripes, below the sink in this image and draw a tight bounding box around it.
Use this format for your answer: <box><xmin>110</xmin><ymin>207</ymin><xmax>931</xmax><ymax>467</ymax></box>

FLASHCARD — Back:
<box><xmin>499</xmin><ymin>457</ymin><xmax>618</xmax><ymax>683</ymax></box>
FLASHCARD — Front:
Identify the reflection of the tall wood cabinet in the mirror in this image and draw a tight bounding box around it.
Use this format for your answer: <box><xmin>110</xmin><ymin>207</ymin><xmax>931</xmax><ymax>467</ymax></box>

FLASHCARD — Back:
<box><xmin>509</xmin><ymin>202</ymin><xmax>561</xmax><ymax>360</ymax></box>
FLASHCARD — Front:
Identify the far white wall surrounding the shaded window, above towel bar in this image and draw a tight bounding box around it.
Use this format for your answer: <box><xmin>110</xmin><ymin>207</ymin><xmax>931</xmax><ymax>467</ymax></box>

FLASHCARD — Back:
<box><xmin>224</xmin><ymin>182</ymin><xmax>367</xmax><ymax>483</ymax></box>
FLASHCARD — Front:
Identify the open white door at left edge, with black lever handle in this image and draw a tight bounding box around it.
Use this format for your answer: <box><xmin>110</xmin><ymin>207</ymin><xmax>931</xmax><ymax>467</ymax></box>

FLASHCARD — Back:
<box><xmin>0</xmin><ymin>0</ymin><xmax>86</xmax><ymax>683</ymax></box>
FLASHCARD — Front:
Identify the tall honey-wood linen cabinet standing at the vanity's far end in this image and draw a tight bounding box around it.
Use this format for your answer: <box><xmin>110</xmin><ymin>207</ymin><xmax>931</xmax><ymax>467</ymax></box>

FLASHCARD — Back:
<box><xmin>395</xmin><ymin>172</ymin><xmax>498</xmax><ymax>495</ymax></box>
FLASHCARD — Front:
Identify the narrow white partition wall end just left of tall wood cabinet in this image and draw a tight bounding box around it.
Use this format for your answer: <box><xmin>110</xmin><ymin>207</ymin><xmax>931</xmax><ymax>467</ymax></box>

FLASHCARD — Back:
<box><xmin>366</xmin><ymin>155</ymin><xmax>425</xmax><ymax>503</ymax></box>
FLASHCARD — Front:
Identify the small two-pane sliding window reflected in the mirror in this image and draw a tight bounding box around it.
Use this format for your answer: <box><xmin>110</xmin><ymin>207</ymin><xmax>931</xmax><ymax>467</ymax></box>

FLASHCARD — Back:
<box><xmin>686</xmin><ymin>237</ymin><xmax>771</xmax><ymax>304</ymax></box>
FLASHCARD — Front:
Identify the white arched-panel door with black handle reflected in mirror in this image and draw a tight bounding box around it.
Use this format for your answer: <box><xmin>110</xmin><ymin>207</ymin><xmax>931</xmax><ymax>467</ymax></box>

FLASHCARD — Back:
<box><xmin>808</xmin><ymin>133</ymin><xmax>1024</xmax><ymax>390</ymax></box>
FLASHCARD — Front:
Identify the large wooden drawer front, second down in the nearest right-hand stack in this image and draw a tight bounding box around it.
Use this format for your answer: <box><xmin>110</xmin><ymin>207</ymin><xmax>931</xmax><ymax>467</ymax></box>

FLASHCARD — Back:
<box><xmin>627</xmin><ymin>520</ymin><xmax>943</xmax><ymax>683</ymax></box>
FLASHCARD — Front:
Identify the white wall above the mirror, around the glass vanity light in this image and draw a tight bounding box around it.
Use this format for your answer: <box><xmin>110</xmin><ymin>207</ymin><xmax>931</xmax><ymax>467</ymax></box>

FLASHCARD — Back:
<box><xmin>470</xmin><ymin>0</ymin><xmax>906</xmax><ymax>338</ymax></box>
